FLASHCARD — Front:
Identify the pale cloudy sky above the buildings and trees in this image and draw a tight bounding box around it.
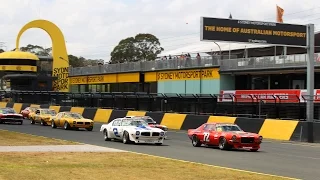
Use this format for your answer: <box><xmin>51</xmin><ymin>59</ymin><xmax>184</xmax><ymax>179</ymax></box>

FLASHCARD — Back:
<box><xmin>0</xmin><ymin>0</ymin><xmax>320</xmax><ymax>61</ymax></box>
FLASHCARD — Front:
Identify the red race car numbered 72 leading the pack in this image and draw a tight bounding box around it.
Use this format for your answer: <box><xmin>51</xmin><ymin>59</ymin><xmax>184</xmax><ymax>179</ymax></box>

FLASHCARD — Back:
<box><xmin>188</xmin><ymin>123</ymin><xmax>262</xmax><ymax>151</ymax></box>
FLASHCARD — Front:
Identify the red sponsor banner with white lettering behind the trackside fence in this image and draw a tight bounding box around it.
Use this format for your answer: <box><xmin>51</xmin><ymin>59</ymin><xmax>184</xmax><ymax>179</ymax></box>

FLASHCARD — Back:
<box><xmin>218</xmin><ymin>89</ymin><xmax>320</xmax><ymax>103</ymax></box>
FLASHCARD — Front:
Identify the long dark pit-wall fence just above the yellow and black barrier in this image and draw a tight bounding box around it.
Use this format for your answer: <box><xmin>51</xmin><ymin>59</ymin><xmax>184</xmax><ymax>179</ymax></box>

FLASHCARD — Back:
<box><xmin>0</xmin><ymin>91</ymin><xmax>320</xmax><ymax>119</ymax></box>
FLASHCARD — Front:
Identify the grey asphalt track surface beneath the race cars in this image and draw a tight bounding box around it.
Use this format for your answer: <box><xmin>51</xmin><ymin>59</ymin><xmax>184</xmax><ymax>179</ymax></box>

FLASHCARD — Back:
<box><xmin>0</xmin><ymin>120</ymin><xmax>320</xmax><ymax>180</ymax></box>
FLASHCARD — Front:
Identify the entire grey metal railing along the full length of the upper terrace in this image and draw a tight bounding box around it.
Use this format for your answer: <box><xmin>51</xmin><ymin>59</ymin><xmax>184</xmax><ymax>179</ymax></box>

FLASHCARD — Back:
<box><xmin>69</xmin><ymin>53</ymin><xmax>320</xmax><ymax>76</ymax></box>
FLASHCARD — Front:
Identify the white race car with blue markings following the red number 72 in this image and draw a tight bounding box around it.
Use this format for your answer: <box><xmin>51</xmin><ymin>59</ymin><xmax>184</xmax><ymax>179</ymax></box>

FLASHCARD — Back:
<box><xmin>100</xmin><ymin>118</ymin><xmax>165</xmax><ymax>145</ymax></box>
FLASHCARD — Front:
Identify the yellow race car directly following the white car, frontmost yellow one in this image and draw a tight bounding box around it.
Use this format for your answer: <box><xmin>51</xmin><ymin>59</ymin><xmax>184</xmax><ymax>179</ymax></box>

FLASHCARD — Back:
<box><xmin>51</xmin><ymin>112</ymin><xmax>94</xmax><ymax>131</ymax></box>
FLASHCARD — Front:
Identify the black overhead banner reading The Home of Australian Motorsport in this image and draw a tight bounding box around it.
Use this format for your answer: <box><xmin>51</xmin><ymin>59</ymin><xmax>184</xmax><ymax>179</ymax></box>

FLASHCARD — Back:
<box><xmin>200</xmin><ymin>17</ymin><xmax>307</xmax><ymax>46</ymax></box>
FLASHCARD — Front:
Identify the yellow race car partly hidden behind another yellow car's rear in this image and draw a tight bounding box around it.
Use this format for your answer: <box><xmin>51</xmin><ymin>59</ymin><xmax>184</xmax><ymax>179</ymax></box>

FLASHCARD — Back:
<box><xmin>30</xmin><ymin>108</ymin><xmax>57</xmax><ymax>126</ymax></box>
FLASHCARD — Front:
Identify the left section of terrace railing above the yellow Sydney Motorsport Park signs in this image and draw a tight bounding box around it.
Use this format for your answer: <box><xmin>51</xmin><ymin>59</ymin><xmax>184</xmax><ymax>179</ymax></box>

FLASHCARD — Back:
<box><xmin>69</xmin><ymin>55</ymin><xmax>236</xmax><ymax>76</ymax></box>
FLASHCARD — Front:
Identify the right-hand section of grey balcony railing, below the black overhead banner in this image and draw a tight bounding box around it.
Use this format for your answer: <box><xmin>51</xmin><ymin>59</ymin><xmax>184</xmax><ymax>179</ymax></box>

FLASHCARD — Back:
<box><xmin>220</xmin><ymin>53</ymin><xmax>320</xmax><ymax>71</ymax></box>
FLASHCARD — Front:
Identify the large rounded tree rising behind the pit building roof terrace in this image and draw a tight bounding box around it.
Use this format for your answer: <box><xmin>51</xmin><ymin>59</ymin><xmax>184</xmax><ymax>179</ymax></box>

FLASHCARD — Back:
<box><xmin>109</xmin><ymin>34</ymin><xmax>164</xmax><ymax>64</ymax></box>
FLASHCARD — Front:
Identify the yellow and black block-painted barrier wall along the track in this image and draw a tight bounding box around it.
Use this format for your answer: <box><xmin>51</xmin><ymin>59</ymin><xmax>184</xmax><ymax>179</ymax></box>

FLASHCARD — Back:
<box><xmin>0</xmin><ymin>102</ymin><xmax>320</xmax><ymax>142</ymax></box>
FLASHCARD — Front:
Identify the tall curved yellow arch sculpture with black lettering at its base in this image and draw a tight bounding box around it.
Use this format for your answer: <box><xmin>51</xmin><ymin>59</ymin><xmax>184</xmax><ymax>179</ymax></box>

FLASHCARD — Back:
<box><xmin>16</xmin><ymin>20</ymin><xmax>69</xmax><ymax>92</ymax></box>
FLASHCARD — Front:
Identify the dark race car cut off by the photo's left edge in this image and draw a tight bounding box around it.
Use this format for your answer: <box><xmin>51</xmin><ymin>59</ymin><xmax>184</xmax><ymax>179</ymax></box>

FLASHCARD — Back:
<box><xmin>0</xmin><ymin>108</ymin><xmax>23</xmax><ymax>124</ymax></box>
